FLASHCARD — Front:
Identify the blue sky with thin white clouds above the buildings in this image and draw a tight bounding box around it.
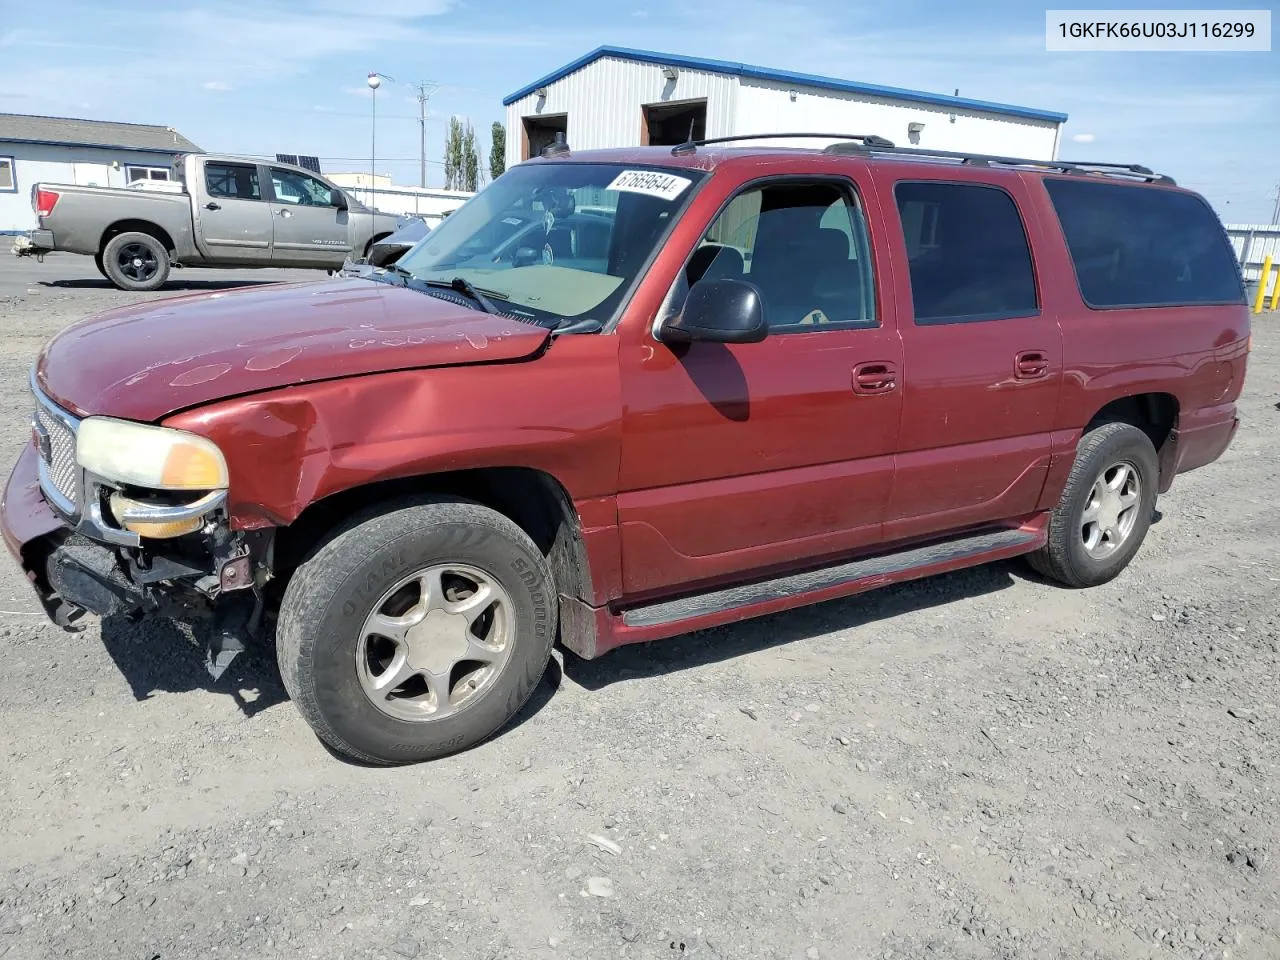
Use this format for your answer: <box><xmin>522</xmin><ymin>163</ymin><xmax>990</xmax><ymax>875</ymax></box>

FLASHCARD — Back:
<box><xmin>0</xmin><ymin>0</ymin><xmax>1280</xmax><ymax>223</ymax></box>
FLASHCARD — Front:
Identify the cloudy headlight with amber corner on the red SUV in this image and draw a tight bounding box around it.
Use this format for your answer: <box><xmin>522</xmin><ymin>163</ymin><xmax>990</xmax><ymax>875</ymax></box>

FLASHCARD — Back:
<box><xmin>76</xmin><ymin>417</ymin><xmax>228</xmax><ymax>490</ymax></box>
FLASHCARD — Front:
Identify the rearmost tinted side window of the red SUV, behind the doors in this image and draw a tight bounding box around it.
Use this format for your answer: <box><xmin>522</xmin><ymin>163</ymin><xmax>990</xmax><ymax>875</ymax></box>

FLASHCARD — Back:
<box><xmin>1044</xmin><ymin>179</ymin><xmax>1244</xmax><ymax>308</ymax></box>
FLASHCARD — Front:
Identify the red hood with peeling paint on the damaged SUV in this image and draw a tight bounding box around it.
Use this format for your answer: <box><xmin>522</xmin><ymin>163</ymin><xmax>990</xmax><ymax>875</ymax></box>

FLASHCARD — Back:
<box><xmin>36</xmin><ymin>279</ymin><xmax>550</xmax><ymax>420</ymax></box>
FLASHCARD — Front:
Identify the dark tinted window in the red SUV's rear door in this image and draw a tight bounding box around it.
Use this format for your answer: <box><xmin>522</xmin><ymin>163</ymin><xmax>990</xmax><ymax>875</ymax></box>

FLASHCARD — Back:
<box><xmin>893</xmin><ymin>182</ymin><xmax>1039</xmax><ymax>324</ymax></box>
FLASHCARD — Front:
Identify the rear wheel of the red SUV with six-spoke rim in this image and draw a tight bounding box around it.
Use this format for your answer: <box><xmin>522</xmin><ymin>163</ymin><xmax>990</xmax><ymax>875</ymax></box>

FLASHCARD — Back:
<box><xmin>1028</xmin><ymin>424</ymin><xmax>1160</xmax><ymax>588</ymax></box>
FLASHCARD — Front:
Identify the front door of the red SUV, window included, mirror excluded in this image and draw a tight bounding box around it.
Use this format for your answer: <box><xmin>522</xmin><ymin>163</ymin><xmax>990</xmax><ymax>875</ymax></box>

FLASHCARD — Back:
<box><xmin>618</xmin><ymin>178</ymin><xmax>902</xmax><ymax>598</ymax></box>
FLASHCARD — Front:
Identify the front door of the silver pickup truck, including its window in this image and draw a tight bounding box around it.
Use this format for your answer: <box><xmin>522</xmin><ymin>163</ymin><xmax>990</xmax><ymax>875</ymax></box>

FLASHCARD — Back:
<box><xmin>270</xmin><ymin>166</ymin><xmax>350</xmax><ymax>268</ymax></box>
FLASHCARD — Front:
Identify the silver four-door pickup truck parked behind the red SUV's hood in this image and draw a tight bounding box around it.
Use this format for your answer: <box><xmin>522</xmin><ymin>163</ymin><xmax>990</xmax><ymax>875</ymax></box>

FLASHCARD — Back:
<box><xmin>31</xmin><ymin>154</ymin><xmax>398</xmax><ymax>291</ymax></box>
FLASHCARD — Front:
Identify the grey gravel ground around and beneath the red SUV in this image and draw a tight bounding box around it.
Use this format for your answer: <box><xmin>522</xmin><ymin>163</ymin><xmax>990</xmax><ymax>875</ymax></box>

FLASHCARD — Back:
<box><xmin>0</xmin><ymin>257</ymin><xmax>1280</xmax><ymax>960</ymax></box>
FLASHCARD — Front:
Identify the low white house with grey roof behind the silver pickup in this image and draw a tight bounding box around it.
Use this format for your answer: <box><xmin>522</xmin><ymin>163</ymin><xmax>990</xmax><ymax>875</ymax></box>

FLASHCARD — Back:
<box><xmin>0</xmin><ymin>114</ymin><xmax>202</xmax><ymax>233</ymax></box>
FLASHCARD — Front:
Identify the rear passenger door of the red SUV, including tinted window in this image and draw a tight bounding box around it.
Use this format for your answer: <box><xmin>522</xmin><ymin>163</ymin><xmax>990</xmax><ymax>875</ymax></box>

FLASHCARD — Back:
<box><xmin>877</xmin><ymin>174</ymin><xmax>1062</xmax><ymax>540</ymax></box>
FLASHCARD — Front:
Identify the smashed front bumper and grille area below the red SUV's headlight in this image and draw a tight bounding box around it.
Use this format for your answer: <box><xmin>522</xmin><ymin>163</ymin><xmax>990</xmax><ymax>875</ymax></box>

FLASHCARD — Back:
<box><xmin>0</xmin><ymin>442</ymin><xmax>270</xmax><ymax>678</ymax></box>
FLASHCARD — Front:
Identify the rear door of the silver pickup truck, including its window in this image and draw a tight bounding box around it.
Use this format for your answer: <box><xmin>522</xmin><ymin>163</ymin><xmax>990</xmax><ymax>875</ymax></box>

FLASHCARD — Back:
<box><xmin>192</xmin><ymin>161</ymin><xmax>271</xmax><ymax>265</ymax></box>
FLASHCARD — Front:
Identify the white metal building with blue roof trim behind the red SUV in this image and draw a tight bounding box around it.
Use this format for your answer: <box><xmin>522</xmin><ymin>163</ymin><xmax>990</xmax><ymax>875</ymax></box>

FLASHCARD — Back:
<box><xmin>503</xmin><ymin>46</ymin><xmax>1066</xmax><ymax>166</ymax></box>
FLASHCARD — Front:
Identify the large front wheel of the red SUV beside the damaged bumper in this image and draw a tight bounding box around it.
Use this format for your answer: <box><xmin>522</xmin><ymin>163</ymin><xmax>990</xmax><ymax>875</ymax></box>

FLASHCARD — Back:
<box><xmin>276</xmin><ymin>500</ymin><xmax>557</xmax><ymax>765</ymax></box>
